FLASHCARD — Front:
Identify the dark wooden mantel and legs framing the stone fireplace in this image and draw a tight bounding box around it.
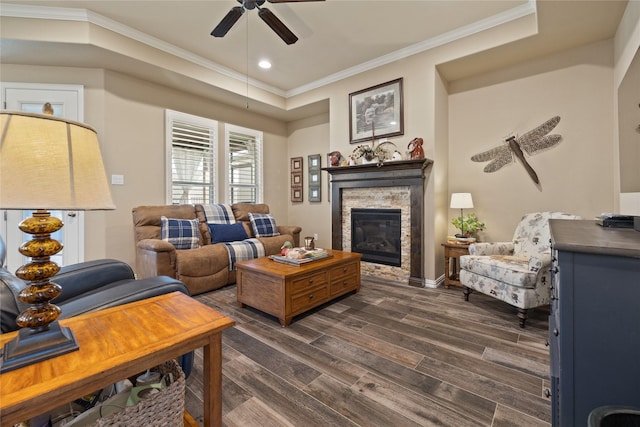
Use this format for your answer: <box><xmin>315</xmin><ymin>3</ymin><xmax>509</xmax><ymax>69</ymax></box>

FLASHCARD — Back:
<box><xmin>322</xmin><ymin>159</ymin><xmax>433</xmax><ymax>287</ymax></box>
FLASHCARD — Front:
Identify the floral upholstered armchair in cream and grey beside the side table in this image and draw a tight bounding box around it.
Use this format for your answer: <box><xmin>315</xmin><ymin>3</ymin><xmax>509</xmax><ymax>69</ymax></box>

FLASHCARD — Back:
<box><xmin>460</xmin><ymin>212</ymin><xmax>580</xmax><ymax>328</ymax></box>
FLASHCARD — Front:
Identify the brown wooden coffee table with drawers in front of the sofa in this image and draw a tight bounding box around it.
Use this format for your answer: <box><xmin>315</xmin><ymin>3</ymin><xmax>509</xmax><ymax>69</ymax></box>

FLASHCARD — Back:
<box><xmin>236</xmin><ymin>250</ymin><xmax>361</xmax><ymax>326</ymax></box>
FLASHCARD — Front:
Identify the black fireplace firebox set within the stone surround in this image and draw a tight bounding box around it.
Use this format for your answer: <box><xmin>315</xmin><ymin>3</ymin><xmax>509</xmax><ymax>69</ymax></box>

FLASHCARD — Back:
<box><xmin>351</xmin><ymin>208</ymin><xmax>402</xmax><ymax>267</ymax></box>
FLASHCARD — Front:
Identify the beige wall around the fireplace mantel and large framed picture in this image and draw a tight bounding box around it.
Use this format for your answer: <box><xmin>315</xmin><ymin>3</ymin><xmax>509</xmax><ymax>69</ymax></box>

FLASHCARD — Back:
<box><xmin>287</xmin><ymin>10</ymin><xmax>535</xmax><ymax>285</ymax></box>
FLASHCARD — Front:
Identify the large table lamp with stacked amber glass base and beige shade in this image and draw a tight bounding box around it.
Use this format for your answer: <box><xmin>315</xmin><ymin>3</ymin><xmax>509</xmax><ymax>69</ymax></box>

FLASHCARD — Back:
<box><xmin>0</xmin><ymin>111</ymin><xmax>115</xmax><ymax>372</ymax></box>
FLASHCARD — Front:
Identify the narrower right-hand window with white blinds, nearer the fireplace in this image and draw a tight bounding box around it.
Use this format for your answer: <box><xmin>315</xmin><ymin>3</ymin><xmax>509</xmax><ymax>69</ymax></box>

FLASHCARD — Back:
<box><xmin>225</xmin><ymin>125</ymin><xmax>262</xmax><ymax>203</ymax></box>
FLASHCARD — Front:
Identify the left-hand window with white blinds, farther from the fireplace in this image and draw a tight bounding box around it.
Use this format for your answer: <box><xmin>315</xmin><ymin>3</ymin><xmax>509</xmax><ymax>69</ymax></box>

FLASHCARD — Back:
<box><xmin>167</xmin><ymin>110</ymin><xmax>217</xmax><ymax>205</ymax></box>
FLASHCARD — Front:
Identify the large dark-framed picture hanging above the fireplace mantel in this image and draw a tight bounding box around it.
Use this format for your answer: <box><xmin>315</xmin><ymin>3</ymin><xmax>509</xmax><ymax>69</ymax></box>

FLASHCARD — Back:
<box><xmin>349</xmin><ymin>77</ymin><xmax>404</xmax><ymax>144</ymax></box>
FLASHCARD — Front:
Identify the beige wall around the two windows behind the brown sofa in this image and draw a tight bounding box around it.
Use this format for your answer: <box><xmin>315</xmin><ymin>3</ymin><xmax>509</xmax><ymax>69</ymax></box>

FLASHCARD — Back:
<box><xmin>2</xmin><ymin>64</ymin><xmax>289</xmax><ymax>265</ymax></box>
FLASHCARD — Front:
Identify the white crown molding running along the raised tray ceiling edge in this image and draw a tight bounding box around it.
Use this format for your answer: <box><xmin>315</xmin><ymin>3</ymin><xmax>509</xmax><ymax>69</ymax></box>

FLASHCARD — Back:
<box><xmin>0</xmin><ymin>0</ymin><xmax>536</xmax><ymax>99</ymax></box>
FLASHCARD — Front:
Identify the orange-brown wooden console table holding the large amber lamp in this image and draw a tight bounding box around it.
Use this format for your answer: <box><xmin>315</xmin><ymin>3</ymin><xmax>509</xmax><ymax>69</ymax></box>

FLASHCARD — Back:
<box><xmin>0</xmin><ymin>292</ymin><xmax>235</xmax><ymax>426</ymax></box>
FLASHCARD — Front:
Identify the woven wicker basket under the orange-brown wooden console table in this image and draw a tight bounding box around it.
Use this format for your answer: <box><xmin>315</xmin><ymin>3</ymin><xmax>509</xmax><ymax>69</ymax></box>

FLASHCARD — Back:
<box><xmin>91</xmin><ymin>360</ymin><xmax>185</xmax><ymax>427</ymax></box>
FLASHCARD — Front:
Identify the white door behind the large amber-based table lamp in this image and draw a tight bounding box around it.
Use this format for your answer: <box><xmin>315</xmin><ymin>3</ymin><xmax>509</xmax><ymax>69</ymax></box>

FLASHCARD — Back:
<box><xmin>0</xmin><ymin>82</ymin><xmax>84</xmax><ymax>272</ymax></box>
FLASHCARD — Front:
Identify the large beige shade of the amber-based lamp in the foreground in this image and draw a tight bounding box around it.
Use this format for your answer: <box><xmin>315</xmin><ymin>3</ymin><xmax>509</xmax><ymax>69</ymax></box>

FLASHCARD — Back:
<box><xmin>0</xmin><ymin>111</ymin><xmax>115</xmax><ymax>210</ymax></box>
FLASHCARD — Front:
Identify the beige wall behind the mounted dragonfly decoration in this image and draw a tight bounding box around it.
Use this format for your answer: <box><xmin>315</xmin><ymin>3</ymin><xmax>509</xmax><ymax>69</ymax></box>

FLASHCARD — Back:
<box><xmin>449</xmin><ymin>41</ymin><xmax>614</xmax><ymax>241</ymax></box>
